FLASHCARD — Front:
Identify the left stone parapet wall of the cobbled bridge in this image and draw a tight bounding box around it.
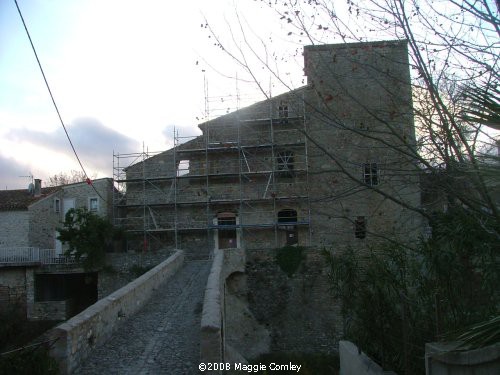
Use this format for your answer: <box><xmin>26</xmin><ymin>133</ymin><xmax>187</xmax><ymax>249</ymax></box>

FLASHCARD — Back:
<box><xmin>49</xmin><ymin>250</ymin><xmax>184</xmax><ymax>374</ymax></box>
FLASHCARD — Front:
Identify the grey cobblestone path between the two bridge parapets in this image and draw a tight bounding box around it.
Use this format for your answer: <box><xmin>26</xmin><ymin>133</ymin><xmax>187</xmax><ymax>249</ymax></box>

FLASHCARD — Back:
<box><xmin>75</xmin><ymin>260</ymin><xmax>211</xmax><ymax>375</ymax></box>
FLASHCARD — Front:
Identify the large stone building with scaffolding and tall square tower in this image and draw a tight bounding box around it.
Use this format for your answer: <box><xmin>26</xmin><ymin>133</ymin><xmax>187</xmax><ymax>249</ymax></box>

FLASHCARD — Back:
<box><xmin>114</xmin><ymin>41</ymin><xmax>421</xmax><ymax>254</ymax></box>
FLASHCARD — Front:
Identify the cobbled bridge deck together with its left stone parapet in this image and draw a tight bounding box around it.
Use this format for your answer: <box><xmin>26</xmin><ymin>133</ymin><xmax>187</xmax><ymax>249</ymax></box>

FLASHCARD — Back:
<box><xmin>50</xmin><ymin>251</ymin><xmax>212</xmax><ymax>375</ymax></box>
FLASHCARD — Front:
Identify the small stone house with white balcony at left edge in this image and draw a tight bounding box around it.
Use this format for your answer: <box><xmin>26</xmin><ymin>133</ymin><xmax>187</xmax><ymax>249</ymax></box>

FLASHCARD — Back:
<box><xmin>0</xmin><ymin>178</ymin><xmax>113</xmax><ymax>320</ymax></box>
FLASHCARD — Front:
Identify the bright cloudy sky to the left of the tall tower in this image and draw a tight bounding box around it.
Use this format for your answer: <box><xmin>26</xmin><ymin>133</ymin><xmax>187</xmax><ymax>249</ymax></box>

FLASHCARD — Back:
<box><xmin>0</xmin><ymin>0</ymin><xmax>301</xmax><ymax>189</ymax></box>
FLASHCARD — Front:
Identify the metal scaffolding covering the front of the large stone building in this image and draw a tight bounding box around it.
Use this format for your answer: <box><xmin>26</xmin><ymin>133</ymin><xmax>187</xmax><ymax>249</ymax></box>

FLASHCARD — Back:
<box><xmin>113</xmin><ymin>94</ymin><xmax>311</xmax><ymax>253</ymax></box>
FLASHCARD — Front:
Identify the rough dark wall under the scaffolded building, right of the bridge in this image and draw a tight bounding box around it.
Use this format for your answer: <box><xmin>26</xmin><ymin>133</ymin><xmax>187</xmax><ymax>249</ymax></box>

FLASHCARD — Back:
<box><xmin>246</xmin><ymin>249</ymin><xmax>342</xmax><ymax>353</ymax></box>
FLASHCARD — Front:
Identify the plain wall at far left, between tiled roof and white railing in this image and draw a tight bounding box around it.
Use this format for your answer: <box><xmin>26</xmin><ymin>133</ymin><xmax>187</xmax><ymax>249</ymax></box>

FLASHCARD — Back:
<box><xmin>0</xmin><ymin>211</ymin><xmax>30</xmax><ymax>247</ymax></box>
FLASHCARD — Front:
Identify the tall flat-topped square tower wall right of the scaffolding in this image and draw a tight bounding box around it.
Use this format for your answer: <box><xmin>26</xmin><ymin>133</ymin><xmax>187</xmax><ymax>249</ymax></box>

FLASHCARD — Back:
<box><xmin>304</xmin><ymin>41</ymin><xmax>422</xmax><ymax>252</ymax></box>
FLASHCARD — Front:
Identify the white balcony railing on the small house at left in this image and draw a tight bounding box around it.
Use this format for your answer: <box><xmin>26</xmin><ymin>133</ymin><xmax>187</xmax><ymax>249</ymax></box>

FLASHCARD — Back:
<box><xmin>0</xmin><ymin>247</ymin><xmax>78</xmax><ymax>265</ymax></box>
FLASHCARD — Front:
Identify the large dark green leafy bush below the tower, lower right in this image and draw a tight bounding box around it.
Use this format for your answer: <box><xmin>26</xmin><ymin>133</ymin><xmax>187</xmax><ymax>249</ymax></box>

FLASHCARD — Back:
<box><xmin>330</xmin><ymin>208</ymin><xmax>500</xmax><ymax>374</ymax></box>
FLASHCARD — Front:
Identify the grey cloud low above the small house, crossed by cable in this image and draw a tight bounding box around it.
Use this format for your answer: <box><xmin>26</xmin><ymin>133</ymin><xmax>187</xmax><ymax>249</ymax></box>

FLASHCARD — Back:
<box><xmin>7</xmin><ymin>117</ymin><xmax>140</xmax><ymax>174</ymax></box>
